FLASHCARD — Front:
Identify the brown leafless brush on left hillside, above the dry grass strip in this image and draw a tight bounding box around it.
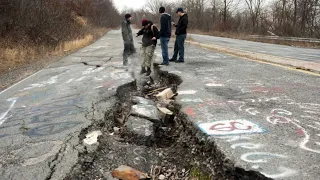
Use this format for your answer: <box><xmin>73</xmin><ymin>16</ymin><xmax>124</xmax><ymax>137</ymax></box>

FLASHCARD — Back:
<box><xmin>0</xmin><ymin>0</ymin><xmax>120</xmax><ymax>46</ymax></box>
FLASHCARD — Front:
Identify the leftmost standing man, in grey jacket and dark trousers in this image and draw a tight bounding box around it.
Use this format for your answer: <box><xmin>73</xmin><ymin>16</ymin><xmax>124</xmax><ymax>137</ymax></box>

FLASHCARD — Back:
<box><xmin>121</xmin><ymin>14</ymin><xmax>136</xmax><ymax>66</ymax></box>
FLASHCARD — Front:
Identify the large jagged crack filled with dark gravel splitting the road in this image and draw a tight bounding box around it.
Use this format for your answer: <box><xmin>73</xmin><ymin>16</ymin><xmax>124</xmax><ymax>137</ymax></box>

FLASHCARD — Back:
<box><xmin>65</xmin><ymin>67</ymin><xmax>269</xmax><ymax>180</ymax></box>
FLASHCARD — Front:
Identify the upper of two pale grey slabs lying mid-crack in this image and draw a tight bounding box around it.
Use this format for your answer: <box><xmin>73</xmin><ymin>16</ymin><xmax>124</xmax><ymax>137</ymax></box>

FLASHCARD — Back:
<box><xmin>131</xmin><ymin>104</ymin><xmax>160</xmax><ymax>121</ymax></box>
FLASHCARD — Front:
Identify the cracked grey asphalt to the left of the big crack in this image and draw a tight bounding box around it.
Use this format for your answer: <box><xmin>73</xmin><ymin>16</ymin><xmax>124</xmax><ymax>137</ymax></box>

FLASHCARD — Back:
<box><xmin>0</xmin><ymin>31</ymin><xmax>133</xmax><ymax>180</ymax></box>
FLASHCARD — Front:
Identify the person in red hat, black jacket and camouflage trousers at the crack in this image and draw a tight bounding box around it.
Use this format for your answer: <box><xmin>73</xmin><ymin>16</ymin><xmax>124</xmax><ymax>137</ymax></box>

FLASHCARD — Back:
<box><xmin>137</xmin><ymin>20</ymin><xmax>160</xmax><ymax>76</ymax></box>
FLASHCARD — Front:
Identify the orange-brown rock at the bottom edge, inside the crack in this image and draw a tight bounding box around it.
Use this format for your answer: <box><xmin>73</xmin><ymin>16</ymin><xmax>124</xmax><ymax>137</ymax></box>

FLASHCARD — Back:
<box><xmin>112</xmin><ymin>165</ymin><xmax>149</xmax><ymax>180</ymax></box>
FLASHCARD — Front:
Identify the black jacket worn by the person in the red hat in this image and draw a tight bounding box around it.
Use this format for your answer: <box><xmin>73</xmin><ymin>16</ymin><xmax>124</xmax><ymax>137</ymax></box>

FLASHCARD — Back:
<box><xmin>137</xmin><ymin>22</ymin><xmax>160</xmax><ymax>47</ymax></box>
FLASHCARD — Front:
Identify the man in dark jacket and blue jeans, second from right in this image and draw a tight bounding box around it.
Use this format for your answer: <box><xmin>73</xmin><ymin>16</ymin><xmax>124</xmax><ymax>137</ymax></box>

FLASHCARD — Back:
<box><xmin>159</xmin><ymin>7</ymin><xmax>171</xmax><ymax>65</ymax></box>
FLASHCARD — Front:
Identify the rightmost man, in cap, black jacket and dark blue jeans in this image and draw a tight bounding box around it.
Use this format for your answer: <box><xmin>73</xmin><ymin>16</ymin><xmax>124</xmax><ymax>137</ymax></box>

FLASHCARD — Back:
<box><xmin>170</xmin><ymin>8</ymin><xmax>188</xmax><ymax>63</ymax></box>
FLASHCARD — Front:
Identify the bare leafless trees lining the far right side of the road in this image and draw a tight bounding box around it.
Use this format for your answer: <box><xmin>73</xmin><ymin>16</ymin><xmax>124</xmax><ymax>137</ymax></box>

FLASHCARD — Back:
<box><xmin>129</xmin><ymin>0</ymin><xmax>320</xmax><ymax>38</ymax></box>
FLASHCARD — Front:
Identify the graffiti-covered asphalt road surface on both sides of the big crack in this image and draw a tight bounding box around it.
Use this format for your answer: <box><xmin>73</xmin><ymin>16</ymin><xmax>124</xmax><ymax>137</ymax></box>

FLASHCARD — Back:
<box><xmin>0</xmin><ymin>28</ymin><xmax>320</xmax><ymax>180</ymax></box>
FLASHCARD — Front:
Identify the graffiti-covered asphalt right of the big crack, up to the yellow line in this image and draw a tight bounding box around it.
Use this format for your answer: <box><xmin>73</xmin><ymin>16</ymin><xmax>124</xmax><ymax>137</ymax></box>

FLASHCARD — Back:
<box><xmin>158</xmin><ymin>35</ymin><xmax>320</xmax><ymax>180</ymax></box>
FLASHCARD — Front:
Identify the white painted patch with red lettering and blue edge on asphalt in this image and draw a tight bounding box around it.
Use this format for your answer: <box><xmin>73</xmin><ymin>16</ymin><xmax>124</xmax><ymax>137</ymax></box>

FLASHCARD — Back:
<box><xmin>198</xmin><ymin>119</ymin><xmax>267</xmax><ymax>136</ymax></box>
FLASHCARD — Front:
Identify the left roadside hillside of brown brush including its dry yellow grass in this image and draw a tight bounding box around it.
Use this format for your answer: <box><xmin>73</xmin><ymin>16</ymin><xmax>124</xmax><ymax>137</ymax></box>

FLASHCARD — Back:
<box><xmin>0</xmin><ymin>0</ymin><xmax>121</xmax><ymax>74</ymax></box>
